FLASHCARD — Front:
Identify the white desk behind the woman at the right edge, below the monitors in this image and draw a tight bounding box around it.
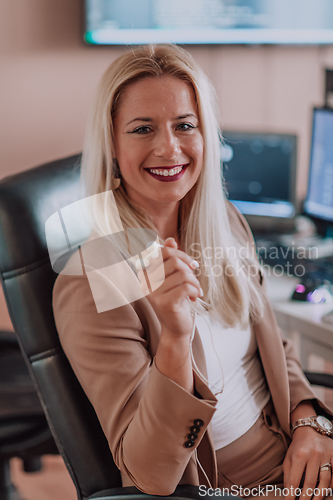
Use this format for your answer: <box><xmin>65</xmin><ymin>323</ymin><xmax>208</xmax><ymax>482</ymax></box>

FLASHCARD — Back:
<box><xmin>266</xmin><ymin>276</ymin><xmax>333</xmax><ymax>371</ymax></box>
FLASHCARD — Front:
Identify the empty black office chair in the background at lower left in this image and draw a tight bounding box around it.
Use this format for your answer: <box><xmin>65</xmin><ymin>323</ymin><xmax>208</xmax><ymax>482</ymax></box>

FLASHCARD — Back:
<box><xmin>0</xmin><ymin>331</ymin><xmax>58</xmax><ymax>500</ymax></box>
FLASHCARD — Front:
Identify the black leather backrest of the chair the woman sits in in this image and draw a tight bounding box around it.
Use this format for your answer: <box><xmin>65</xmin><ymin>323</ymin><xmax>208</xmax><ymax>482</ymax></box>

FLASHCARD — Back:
<box><xmin>0</xmin><ymin>155</ymin><xmax>121</xmax><ymax>499</ymax></box>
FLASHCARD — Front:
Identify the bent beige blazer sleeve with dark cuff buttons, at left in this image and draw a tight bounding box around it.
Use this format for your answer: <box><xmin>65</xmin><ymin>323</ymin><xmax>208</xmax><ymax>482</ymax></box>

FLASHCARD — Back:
<box><xmin>53</xmin><ymin>268</ymin><xmax>217</xmax><ymax>495</ymax></box>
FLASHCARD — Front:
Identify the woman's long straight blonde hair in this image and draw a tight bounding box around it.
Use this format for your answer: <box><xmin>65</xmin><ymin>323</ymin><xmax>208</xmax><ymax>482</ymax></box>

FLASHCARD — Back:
<box><xmin>82</xmin><ymin>45</ymin><xmax>263</xmax><ymax>327</ymax></box>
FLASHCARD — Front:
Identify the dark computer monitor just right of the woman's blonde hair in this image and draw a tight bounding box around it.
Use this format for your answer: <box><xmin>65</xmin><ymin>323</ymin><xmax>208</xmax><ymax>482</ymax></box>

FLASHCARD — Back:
<box><xmin>221</xmin><ymin>132</ymin><xmax>297</xmax><ymax>218</ymax></box>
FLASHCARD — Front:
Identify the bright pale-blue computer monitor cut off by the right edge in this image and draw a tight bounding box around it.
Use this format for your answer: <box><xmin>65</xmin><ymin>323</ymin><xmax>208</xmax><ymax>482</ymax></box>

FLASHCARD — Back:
<box><xmin>304</xmin><ymin>108</ymin><xmax>333</xmax><ymax>233</ymax></box>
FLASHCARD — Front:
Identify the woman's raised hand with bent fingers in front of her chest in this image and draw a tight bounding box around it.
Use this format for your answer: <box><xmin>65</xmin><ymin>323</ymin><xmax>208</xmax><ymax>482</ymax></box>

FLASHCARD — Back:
<box><xmin>139</xmin><ymin>238</ymin><xmax>202</xmax><ymax>337</ymax></box>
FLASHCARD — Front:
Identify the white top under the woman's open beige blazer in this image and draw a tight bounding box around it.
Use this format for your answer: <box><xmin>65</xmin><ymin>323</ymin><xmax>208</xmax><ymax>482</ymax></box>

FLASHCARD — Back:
<box><xmin>196</xmin><ymin>313</ymin><xmax>270</xmax><ymax>450</ymax></box>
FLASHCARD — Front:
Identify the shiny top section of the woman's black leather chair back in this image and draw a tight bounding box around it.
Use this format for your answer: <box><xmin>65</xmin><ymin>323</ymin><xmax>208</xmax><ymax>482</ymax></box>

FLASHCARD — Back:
<box><xmin>0</xmin><ymin>155</ymin><xmax>82</xmax><ymax>273</ymax></box>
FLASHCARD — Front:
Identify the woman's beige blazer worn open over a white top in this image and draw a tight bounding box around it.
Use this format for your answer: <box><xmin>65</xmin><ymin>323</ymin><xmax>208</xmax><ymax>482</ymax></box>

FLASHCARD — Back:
<box><xmin>53</xmin><ymin>204</ymin><xmax>328</xmax><ymax>495</ymax></box>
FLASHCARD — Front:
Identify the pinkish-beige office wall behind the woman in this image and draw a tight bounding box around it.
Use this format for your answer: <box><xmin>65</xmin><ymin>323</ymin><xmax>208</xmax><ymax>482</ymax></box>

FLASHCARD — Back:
<box><xmin>0</xmin><ymin>0</ymin><xmax>333</xmax><ymax>328</ymax></box>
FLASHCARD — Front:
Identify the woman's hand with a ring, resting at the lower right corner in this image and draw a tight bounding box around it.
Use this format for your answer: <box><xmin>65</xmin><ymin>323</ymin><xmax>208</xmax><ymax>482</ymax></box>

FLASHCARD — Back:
<box><xmin>283</xmin><ymin>427</ymin><xmax>333</xmax><ymax>500</ymax></box>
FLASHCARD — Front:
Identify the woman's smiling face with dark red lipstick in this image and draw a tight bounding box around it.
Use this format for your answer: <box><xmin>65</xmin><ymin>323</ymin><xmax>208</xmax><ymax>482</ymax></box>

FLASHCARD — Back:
<box><xmin>114</xmin><ymin>75</ymin><xmax>204</xmax><ymax>215</ymax></box>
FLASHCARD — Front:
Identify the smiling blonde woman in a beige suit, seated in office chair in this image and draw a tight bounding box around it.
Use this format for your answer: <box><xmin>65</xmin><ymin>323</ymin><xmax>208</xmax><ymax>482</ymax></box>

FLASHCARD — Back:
<box><xmin>54</xmin><ymin>46</ymin><xmax>333</xmax><ymax>499</ymax></box>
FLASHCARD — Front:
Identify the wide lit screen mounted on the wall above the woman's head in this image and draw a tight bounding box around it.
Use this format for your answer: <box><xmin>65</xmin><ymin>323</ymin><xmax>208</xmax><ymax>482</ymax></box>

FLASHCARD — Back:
<box><xmin>84</xmin><ymin>0</ymin><xmax>333</xmax><ymax>45</ymax></box>
